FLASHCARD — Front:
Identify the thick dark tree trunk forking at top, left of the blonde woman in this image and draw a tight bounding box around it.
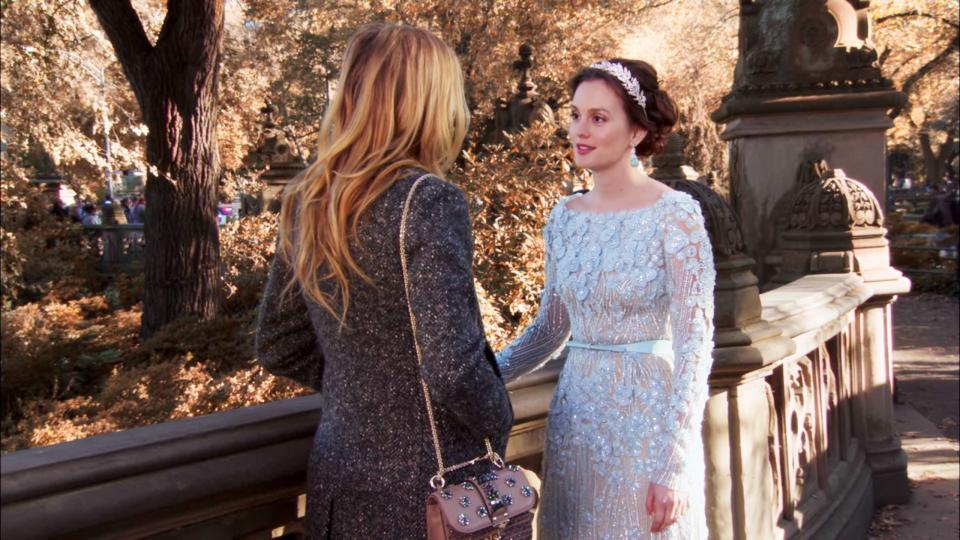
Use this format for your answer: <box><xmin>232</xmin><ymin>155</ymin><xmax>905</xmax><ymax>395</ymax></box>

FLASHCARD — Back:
<box><xmin>90</xmin><ymin>0</ymin><xmax>224</xmax><ymax>337</ymax></box>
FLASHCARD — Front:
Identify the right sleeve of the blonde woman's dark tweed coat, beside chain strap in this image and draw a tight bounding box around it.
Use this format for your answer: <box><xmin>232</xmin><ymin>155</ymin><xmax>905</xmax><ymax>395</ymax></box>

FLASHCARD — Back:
<box><xmin>403</xmin><ymin>178</ymin><xmax>513</xmax><ymax>438</ymax></box>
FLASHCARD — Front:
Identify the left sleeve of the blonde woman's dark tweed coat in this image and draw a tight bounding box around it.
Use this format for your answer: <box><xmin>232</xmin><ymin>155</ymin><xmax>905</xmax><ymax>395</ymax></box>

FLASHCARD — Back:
<box><xmin>254</xmin><ymin>238</ymin><xmax>323</xmax><ymax>391</ymax></box>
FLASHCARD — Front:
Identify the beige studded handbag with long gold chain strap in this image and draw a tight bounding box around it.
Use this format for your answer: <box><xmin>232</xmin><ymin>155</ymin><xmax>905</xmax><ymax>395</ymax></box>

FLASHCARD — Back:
<box><xmin>400</xmin><ymin>174</ymin><xmax>538</xmax><ymax>540</ymax></box>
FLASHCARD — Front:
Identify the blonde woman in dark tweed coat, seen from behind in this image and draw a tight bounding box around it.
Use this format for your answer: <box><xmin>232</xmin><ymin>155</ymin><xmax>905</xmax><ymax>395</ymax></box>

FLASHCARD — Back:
<box><xmin>256</xmin><ymin>24</ymin><xmax>513</xmax><ymax>539</ymax></box>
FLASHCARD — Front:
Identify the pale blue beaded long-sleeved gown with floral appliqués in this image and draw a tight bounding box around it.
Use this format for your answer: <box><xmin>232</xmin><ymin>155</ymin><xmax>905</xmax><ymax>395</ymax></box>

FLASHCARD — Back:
<box><xmin>498</xmin><ymin>191</ymin><xmax>715</xmax><ymax>540</ymax></box>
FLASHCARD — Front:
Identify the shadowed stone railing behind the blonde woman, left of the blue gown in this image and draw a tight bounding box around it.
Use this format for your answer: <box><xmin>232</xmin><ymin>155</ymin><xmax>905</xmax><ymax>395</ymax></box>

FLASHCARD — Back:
<box><xmin>0</xmin><ymin>359</ymin><xmax>563</xmax><ymax>539</ymax></box>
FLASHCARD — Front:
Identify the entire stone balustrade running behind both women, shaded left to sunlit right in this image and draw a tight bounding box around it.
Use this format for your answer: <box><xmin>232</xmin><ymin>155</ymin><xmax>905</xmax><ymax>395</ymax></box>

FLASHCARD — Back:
<box><xmin>0</xmin><ymin>274</ymin><xmax>905</xmax><ymax>539</ymax></box>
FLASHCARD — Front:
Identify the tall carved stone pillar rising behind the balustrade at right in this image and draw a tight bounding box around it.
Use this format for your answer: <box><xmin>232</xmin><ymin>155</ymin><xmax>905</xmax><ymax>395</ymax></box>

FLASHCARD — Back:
<box><xmin>713</xmin><ymin>0</ymin><xmax>905</xmax><ymax>283</ymax></box>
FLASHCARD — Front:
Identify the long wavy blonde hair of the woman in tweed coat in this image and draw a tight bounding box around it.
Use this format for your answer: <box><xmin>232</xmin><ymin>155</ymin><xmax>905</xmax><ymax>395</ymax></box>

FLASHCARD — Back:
<box><xmin>277</xmin><ymin>24</ymin><xmax>470</xmax><ymax>325</ymax></box>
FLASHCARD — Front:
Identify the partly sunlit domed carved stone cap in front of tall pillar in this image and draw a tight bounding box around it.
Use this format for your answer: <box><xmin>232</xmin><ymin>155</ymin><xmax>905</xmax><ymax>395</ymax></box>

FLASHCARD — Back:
<box><xmin>785</xmin><ymin>169</ymin><xmax>883</xmax><ymax>231</ymax></box>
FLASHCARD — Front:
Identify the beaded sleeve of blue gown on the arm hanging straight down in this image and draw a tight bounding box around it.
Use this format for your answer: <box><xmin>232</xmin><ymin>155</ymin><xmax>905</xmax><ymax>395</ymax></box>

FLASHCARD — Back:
<box><xmin>651</xmin><ymin>196</ymin><xmax>716</xmax><ymax>489</ymax></box>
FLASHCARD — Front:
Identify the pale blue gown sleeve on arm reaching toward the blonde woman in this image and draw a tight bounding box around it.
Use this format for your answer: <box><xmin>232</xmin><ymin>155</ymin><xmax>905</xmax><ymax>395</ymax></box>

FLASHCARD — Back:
<box><xmin>497</xmin><ymin>205</ymin><xmax>570</xmax><ymax>382</ymax></box>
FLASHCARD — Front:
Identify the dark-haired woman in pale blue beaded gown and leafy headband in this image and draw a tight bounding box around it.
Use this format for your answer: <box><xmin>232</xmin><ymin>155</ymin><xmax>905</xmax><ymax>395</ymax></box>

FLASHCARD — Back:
<box><xmin>498</xmin><ymin>59</ymin><xmax>715</xmax><ymax>540</ymax></box>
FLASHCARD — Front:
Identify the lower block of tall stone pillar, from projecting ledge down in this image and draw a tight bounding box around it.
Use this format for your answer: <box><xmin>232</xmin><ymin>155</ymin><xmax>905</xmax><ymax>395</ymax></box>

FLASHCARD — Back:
<box><xmin>721</xmin><ymin>96</ymin><xmax>897</xmax><ymax>283</ymax></box>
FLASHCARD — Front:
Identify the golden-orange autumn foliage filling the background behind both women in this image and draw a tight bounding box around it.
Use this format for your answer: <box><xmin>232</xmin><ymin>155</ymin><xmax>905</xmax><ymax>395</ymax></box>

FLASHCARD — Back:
<box><xmin>0</xmin><ymin>0</ymin><xmax>957</xmax><ymax>451</ymax></box>
